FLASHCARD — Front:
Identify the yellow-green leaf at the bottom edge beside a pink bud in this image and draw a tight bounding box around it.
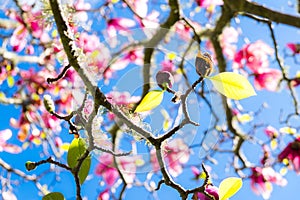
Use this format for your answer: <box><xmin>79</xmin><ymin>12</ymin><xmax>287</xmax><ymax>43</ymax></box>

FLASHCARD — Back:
<box><xmin>219</xmin><ymin>177</ymin><xmax>243</xmax><ymax>200</ymax></box>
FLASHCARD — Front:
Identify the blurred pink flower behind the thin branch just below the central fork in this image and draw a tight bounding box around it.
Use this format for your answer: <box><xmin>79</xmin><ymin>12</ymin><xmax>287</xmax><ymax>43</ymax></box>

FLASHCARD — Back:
<box><xmin>151</xmin><ymin>138</ymin><xmax>190</xmax><ymax>177</ymax></box>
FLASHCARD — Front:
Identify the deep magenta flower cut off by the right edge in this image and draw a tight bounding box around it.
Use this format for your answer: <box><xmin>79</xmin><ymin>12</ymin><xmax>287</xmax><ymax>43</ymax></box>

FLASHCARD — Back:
<box><xmin>278</xmin><ymin>138</ymin><xmax>300</xmax><ymax>174</ymax></box>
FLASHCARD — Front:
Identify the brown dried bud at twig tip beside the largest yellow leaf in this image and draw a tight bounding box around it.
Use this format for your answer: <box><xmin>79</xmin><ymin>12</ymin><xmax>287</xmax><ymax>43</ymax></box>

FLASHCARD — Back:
<box><xmin>195</xmin><ymin>51</ymin><xmax>213</xmax><ymax>77</ymax></box>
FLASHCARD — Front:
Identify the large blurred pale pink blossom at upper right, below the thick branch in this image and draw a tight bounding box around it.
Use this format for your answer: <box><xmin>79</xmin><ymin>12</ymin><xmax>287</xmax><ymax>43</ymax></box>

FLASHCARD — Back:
<box><xmin>233</xmin><ymin>40</ymin><xmax>274</xmax><ymax>73</ymax></box>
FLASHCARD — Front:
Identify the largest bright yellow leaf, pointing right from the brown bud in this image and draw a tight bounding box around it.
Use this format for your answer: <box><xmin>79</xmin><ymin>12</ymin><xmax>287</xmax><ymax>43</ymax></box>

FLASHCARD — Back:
<box><xmin>206</xmin><ymin>72</ymin><xmax>256</xmax><ymax>100</ymax></box>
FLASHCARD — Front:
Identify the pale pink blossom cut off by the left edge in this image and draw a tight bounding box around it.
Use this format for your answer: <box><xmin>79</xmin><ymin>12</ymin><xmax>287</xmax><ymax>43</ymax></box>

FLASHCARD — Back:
<box><xmin>0</xmin><ymin>129</ymin><xmax>22</xmax><ymax>153</ymax></box>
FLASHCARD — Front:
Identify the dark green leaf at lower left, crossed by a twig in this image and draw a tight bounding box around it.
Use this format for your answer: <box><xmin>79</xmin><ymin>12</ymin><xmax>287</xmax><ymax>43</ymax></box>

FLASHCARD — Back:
<box><xmin>67</xmin><ymin>138</ymin><xmax>91</xmax><ymax>184</ymax></box>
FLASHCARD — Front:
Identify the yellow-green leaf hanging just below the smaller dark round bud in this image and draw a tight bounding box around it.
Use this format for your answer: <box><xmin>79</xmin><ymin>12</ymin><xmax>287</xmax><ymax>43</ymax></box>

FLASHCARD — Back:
<box><xmin>134</xmin><ymin>90</ymin><xmax>164</xmax><ymax>112</ymax></box>
